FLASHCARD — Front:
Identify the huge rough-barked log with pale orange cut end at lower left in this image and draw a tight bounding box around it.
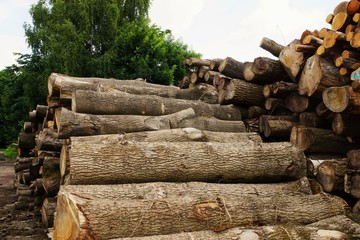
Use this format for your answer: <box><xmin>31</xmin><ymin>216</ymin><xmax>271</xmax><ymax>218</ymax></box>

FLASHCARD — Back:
<box><xmin>54</xmin><ymin>182</ymin><xmax>347</xmax><ymax>239</ymax></box>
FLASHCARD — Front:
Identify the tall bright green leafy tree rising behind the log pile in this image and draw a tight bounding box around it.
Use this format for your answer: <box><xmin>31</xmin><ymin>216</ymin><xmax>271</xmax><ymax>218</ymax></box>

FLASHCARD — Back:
<box><xmin>25</xmin><ymin>0</ymin><xmax>199</xmax><ymax>84</ymax></box>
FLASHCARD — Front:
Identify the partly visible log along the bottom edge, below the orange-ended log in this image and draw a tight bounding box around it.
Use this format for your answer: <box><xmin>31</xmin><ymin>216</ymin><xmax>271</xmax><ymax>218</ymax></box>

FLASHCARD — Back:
<box><xmin>111</xmin><ymin>215</ymin><xmax>360</xmax><ymax>240</ymax></box>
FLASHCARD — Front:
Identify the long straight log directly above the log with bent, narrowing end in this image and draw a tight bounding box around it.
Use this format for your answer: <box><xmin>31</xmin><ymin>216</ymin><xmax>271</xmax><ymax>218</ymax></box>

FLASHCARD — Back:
<box><xmin>72</xmin><ymin>90</ymin><xmax>241</xmax><ymax>120</ymax></box>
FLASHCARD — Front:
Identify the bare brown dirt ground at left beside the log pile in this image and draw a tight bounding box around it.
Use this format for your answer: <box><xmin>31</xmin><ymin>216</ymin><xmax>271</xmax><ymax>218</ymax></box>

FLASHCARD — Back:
<box><xmin>0</xmin><ymin>161</ymin><xmax>49</xmax><ymax>240</ymax></box>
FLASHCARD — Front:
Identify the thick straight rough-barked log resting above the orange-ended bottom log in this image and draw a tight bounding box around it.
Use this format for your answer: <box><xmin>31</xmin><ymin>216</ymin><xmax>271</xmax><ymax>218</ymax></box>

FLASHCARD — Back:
<box><xmin>70</xmin><ymin>138</ymin><xmax>306</xmax><ymax>184</ymax></box>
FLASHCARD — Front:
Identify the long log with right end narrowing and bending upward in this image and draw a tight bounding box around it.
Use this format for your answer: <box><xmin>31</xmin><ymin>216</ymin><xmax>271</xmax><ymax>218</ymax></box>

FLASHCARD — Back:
<box><xmin>55</xmin><ymin>108</ymin><xmax>195</xmax><ymax>138</ymax></box>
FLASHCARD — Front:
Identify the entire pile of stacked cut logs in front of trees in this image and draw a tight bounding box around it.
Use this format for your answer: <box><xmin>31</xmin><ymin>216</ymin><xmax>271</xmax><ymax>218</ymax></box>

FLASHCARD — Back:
<box><xmin>11</xmin><ymin>1</ymin><xmax>360</xmax><ymax>240</ymax></box>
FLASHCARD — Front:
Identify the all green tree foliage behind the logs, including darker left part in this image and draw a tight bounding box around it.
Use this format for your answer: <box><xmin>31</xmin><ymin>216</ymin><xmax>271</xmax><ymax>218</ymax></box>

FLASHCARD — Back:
<box><xmin>0</xmin><ymin>0</ymin><xmax>200</xmax><ymax>147</ymax></box>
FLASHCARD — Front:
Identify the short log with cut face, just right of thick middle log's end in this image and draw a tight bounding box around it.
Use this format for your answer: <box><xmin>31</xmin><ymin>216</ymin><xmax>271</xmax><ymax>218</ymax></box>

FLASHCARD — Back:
<box><xmin>316</xmin><ymin>158</ymin><xmax>348</xmax><ymax>193</ymax></box>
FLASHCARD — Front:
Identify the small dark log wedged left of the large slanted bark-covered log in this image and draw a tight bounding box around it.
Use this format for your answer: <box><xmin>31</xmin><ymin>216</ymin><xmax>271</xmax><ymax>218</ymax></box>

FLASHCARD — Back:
<box><xmin>263</xmin><ymin>81</ymin><xmax>299</xmax><ymax>98</ymax></box>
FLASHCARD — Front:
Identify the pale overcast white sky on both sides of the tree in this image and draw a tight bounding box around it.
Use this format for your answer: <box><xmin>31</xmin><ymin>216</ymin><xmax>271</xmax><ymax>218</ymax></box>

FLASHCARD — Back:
<box><xmin>0</xmin><ymin>0</ymin><xmax>341</xmax><ymax>69</ymax></box>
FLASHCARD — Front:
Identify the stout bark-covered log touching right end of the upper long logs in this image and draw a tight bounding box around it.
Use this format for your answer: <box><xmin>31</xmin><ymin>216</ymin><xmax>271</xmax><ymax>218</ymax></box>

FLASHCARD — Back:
<box><xmin>225</xmin><ymin>79</ymin><xmax>265</xmax><ymax>106</ymax></box>
